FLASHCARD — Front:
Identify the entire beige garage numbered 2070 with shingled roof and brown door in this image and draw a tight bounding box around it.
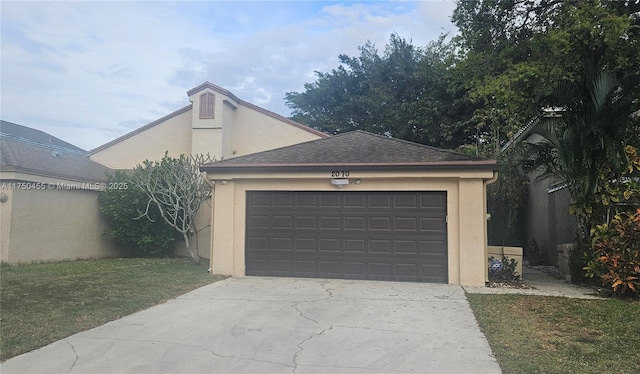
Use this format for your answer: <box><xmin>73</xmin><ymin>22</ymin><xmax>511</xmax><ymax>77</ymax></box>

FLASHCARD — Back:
<box><xmin>201</xmin><ymin>131</ymin><xmax>496</xmax><ymax>286</ymax></box>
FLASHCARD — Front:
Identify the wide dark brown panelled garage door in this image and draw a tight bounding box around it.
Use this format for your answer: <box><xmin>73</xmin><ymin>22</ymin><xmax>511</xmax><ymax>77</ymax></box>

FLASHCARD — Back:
<box><xmin>246</xmin><ymin>191</ymin><xmax>447</xmax><ymax>283</ymax></box>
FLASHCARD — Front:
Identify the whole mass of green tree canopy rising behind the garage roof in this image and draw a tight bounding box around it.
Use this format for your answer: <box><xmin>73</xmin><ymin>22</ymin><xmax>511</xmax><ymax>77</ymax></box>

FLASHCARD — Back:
<box><xmin>285</xmin><ymin>0</ymin><xmax>640</xmax><ymax>156</ymax></box>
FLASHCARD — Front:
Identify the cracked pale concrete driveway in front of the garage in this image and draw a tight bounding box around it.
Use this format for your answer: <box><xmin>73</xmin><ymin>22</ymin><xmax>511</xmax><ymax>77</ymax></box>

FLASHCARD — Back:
<box><xmin>0</xmin><ymin>277</ymin><xmax>500</xmax><ymax>374</ymax></box>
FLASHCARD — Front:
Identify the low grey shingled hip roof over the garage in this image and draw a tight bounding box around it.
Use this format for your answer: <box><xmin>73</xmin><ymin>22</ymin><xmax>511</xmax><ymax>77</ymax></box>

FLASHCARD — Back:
<box><xmin>201</xmin><ymin>130</ymin><xmax>497</xmax><ymax>173</ymax></box>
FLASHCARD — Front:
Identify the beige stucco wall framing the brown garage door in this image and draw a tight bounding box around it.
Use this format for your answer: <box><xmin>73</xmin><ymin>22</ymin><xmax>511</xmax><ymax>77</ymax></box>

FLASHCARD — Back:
<box><xmin>211</xmin><ymin>172</ymin><xmax>492</xmax><ymax>286</ymax></box>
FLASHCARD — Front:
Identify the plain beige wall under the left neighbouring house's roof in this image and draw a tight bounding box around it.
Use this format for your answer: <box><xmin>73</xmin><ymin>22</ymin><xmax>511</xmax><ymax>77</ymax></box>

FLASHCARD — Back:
<box><xmin>2</xmin><ymin>183</ymin><xmax>122</xmax><ymax>263</ymax></box>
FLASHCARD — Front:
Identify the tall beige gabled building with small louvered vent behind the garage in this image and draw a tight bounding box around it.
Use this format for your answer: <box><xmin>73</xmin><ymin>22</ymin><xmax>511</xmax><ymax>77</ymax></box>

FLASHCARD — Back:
<box><xmin>88</xmin><ymin>82</ymin><xmax>328</xmax><ymax>258</ymax></box>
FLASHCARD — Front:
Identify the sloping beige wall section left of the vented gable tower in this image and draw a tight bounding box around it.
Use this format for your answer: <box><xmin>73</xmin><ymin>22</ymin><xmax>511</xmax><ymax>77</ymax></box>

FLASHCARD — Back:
<box><xmin>91</xmin><ymin>110</ymin><xmax>191</xmax><ymax>169</ymax></box>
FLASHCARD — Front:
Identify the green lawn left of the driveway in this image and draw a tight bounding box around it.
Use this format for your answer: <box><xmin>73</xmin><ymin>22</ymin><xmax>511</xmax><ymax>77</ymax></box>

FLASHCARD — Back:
<box><xmin>0</xmin><ymin>259</ymin><xmax>226</xmax><ymax>361</ymax></box>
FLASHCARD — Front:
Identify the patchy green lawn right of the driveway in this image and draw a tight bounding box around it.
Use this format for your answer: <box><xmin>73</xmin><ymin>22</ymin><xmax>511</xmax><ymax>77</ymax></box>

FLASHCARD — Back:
<box><xmin>467</xmin><ymin>294</ymin><xmax>640</xmax><ymax>374</ymax></box>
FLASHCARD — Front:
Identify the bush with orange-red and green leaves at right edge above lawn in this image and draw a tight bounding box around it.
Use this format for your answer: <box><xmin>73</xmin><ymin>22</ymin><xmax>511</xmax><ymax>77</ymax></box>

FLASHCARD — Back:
<box><xmin>584</xmin><ymin>209</ymin><xmax>640</xmax><ymax>297</ymax></box>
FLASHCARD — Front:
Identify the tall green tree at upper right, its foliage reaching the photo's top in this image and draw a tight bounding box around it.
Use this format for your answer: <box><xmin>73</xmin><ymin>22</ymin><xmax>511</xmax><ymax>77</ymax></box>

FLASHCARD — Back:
<box><xmin>452</xmin><ymin>0</ymin><xmax>640</xmax><ymax>156</ymax></box>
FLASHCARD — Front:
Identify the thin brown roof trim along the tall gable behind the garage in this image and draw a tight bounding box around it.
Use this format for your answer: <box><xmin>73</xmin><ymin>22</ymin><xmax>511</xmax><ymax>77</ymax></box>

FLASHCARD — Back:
<box><xmin>88</xmin><ymin>82</ymin><xmax>329</xmax><ymax>155</ymax></box>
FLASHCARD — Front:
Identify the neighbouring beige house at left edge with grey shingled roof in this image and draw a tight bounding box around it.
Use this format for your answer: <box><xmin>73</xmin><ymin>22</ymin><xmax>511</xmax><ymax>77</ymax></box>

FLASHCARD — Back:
<box><xmin>0</xmin><ymin>121</ymin><xmax>121</xmax><ymax>263</ymax></box>
